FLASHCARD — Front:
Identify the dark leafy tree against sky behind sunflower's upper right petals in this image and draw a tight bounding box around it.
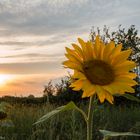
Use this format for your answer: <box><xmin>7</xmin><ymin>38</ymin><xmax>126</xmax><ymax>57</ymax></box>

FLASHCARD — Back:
<box><xmin>90</xmin><ymin>25</ymin><xmax>140</xmax><ymax>66</ymax></box>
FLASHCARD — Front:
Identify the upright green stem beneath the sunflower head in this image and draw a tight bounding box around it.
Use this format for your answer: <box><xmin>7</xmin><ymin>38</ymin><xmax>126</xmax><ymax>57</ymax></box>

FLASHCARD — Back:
<box><xmin>87</xmin><ymin>96</ymin><xmax>94</xmax><ymax>140</ymax></box>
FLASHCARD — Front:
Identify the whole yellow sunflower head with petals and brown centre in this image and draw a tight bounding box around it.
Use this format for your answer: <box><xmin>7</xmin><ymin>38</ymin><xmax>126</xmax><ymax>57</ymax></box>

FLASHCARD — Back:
<box><xmin>63</xmin><ymin>36</ymin><xmax>137</xmax><ymax>103</ymax></box>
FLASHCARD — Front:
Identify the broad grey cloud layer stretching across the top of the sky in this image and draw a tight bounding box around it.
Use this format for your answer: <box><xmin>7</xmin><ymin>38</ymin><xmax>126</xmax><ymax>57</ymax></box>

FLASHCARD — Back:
<box><xmin>0</xmin><ymin>0</ymin><xmax>140</xmax><ymax>38</ymax></box>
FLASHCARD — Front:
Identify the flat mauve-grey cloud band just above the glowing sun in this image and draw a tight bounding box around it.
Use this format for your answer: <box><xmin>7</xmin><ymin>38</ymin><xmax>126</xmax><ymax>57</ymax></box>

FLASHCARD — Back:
<box><xmin>0</xmin><ymin>61</ymin><xmax>63</xmax><ymax>74</ymax></box>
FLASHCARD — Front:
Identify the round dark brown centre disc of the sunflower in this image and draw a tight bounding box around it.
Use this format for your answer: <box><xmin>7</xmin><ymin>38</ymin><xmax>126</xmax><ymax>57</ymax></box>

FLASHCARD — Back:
<box><xmin>83</xmin><ymin>60</ymin><xmax>115</xmax><ymax>85</ymax></box>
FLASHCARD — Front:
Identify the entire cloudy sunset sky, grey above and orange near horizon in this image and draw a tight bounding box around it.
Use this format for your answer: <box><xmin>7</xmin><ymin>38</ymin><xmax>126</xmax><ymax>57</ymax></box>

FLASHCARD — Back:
<box><xmin>0</xmin><ymin>0</ymin><xmax>140</xmax><ymax>96</ymax></box>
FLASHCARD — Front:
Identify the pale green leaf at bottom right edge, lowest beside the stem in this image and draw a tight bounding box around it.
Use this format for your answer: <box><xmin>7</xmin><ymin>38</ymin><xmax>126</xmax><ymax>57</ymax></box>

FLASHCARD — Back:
<box><xmin>99</xmin><ymin>130</ymin><xmax>140</xmax><ymax>138</ymax></box>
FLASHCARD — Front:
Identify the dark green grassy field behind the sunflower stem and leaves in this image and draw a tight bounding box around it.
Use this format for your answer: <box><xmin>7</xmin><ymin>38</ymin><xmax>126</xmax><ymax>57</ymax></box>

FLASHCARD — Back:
<box><xmin>0</xmin><ymin>101</ymin><xmax>140</xmax><ymax>140</ymax></box>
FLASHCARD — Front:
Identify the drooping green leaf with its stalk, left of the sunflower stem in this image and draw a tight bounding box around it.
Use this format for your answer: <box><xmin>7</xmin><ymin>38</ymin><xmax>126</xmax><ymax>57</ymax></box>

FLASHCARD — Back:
<box><xmin>34</xmin><ymin>101</ymin><xmax>85</xmax><ymax>125</ymax></box>
